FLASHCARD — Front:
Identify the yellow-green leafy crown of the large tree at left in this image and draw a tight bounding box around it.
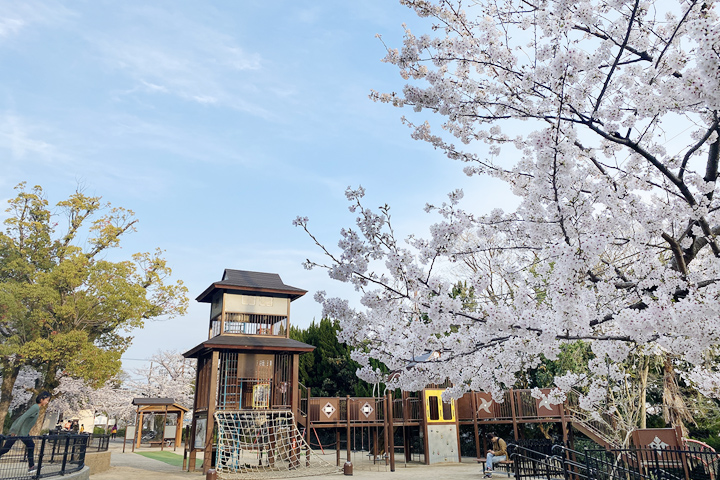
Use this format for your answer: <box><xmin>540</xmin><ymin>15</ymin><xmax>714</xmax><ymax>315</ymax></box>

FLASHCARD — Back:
<box><xmin>0</xmin><ymin>183</ymin><xmax>187</xmax><ymax>425</ymax></box>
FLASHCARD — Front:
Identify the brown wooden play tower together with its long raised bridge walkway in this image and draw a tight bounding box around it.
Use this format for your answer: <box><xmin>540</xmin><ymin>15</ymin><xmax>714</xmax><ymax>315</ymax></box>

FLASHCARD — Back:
<box><xmin>184</xmin><ymin>269</ymin><xmax>593</xmax><ymax>472</ymax></box>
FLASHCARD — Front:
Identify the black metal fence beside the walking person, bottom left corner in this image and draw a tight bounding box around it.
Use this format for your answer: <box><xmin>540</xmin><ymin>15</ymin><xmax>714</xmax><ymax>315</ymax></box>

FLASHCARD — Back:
<box><xmin>0</xmin><ymin>434</ymin><xmax>90</xmax><ymax>480</ymax></box>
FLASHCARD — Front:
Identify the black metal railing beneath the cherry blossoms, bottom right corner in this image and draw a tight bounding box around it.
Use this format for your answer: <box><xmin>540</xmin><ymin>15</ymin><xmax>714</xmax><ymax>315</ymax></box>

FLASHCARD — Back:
<box><xmin>510</xmin><ymin>445</ymin><xmax>720</xmax><ymax>480</ymax></box>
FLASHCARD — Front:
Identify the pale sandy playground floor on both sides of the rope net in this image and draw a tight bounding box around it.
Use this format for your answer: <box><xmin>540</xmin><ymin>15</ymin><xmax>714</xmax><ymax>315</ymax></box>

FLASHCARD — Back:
<box><xmin>90</xmin><ymin>440</ymin><xmax>490</xmax><ymax>480</ymax></box>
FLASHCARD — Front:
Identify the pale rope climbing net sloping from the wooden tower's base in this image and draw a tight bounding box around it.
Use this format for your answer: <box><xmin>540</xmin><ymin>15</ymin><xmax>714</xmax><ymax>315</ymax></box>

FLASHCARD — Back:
<box><xmin>215</xmin><ymin>410</ymin><xmax>339</xmax><ymax>480</ymax></box>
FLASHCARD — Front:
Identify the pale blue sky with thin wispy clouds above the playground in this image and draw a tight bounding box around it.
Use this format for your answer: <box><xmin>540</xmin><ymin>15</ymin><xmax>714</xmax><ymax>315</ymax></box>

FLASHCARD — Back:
<box><xmin>0</xmin><ymin>0</ymin><xmax>507</xmax><ymax>369</ymax></box>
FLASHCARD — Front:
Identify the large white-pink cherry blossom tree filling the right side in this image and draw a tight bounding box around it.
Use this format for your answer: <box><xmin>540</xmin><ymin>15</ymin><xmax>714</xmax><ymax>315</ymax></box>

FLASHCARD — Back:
<box><xmin>295</xmin><ymin>0</ymin><xmax>720</xmax><ymax>416</ymax></box>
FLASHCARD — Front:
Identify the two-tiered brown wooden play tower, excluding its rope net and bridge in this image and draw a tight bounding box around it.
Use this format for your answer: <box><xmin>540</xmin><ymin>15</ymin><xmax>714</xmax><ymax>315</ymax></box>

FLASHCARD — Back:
<box><xmin>184</xmin><ymin>269</ymin><xmax>315</xmax><ymax>472</ymax></box>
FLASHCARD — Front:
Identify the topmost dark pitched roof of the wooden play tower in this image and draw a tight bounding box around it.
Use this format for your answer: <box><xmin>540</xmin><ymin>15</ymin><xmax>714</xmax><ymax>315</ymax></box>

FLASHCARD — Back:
<box><xmin>196</xmin><ymin>268</ymin><xmax>307</xmax><ymax>303</ymax></box>
